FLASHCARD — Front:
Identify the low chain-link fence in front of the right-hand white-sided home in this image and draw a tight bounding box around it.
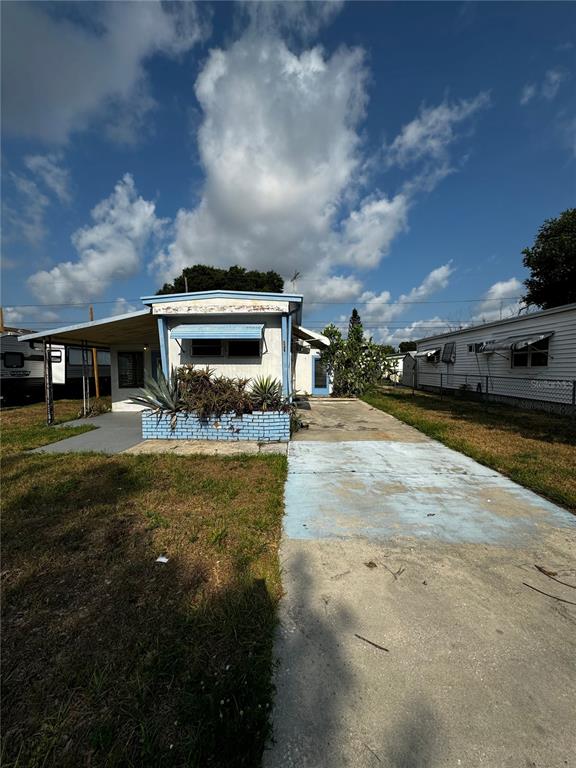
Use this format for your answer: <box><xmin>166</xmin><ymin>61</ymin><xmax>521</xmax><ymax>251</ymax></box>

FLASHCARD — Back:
<box><xmin>414</xmin><ymin>371</ymin><xmax>576</xmax><ymax>411</ymax></box>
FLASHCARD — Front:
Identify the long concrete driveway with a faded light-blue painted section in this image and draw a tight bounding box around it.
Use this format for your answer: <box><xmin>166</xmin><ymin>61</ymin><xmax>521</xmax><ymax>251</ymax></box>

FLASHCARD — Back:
<box><xmin>264</xmin><ymin>402</ymin><xmax>576</xmax><ymax>768</ymax></box>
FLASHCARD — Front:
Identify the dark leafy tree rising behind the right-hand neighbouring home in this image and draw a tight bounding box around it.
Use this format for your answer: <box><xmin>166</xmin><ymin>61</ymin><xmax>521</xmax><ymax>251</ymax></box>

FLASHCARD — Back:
<box><xmin>522</xmin><ymin>208</ymin><xmax>576</xmax><ymax>309</ymax></box>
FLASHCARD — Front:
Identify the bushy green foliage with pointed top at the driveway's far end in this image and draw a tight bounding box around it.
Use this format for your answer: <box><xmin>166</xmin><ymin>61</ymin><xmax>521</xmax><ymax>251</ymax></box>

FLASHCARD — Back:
<box><xmin>320</xmin><ymin>309</ymin><xmax>390</xmax><ymax>397</ymax></box>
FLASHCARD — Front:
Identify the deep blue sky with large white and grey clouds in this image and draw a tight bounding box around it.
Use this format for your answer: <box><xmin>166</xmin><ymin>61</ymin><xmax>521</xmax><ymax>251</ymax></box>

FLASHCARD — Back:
<box><xmin>2</xmin><ymin>2</ymin><xmax>576</xmax><ymax>343</ymax></box>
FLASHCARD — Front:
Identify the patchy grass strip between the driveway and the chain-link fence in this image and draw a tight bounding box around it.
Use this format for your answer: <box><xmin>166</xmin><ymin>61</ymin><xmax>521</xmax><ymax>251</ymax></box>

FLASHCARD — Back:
<box><xmin>364</xmin><ymin>388</ymin><xmax>576</xmax><ymax>511</ymax></box>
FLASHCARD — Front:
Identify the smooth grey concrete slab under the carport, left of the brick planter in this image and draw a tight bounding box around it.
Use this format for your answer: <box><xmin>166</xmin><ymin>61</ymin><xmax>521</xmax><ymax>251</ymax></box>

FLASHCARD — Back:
<box><xmin>32</xmin><ymin>413</ymin><xmax>142</xmax><ymax>453</ymax></box>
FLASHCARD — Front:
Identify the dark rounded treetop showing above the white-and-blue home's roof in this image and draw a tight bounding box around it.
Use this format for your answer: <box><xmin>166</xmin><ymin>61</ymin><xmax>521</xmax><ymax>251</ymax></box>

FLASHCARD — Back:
<box><xmin>158</xmin><ymin>264</ymin><xmax>284</xmax><ymax>294</ymax></box>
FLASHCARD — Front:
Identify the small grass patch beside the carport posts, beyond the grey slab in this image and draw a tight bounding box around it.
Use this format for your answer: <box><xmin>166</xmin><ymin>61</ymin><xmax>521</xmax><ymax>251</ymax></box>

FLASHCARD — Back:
<box><xmin>0</xmin><ymin>400</ymin><xmax>95</xmax><ymax>455</ymax></box>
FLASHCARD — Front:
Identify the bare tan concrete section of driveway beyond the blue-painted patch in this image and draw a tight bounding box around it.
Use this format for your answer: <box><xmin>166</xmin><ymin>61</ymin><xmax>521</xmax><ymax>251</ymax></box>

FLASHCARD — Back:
<box><xmin>292</xmin><ymin>398</ymin><xmax>426</xmax><ymax>443</ymax></box>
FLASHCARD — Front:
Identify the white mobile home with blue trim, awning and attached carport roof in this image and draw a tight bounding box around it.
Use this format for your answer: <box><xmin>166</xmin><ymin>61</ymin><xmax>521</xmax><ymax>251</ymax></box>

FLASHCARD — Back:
<box><xmin>21</xmin><ymin>291</ymin><xmax>330</xmax><ymax>411</ymax></box>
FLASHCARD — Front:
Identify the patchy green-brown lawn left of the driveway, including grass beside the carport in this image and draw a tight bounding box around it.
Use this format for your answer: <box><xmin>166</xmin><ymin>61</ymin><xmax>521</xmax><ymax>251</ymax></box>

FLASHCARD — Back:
<box><xmin>1</xmin><ymin>403</ymin><xmax>286</xmax><ymax>768</ymax></box>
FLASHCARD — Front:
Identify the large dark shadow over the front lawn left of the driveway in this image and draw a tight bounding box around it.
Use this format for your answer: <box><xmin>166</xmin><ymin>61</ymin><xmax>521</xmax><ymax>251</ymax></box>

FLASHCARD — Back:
<box><xmin>2</xmin><ymin>457</ymin><xmax>276</xmax><ymax>768</ymax></box>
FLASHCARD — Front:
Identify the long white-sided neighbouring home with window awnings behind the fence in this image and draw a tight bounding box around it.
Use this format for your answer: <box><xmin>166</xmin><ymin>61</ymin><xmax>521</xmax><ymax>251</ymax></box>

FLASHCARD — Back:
<box><xmin>415</xmin><ymin>304</ymin><xmax>576</xmax><ymax>411</ymax></box>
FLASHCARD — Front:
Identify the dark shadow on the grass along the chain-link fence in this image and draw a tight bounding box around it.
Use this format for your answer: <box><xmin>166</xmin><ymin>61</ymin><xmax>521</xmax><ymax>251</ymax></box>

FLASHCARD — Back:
<box><xmin>365</xmin><ymin>389</ymin><xmax>576</xmax><ymax>445</ymax></box>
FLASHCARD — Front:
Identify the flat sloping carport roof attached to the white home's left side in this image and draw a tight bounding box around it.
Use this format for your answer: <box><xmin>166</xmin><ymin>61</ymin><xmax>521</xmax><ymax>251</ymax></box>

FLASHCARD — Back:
<box><xmin>19</xmin><ymin>308</ymin><xmax>158</xmax><ymax>347</ymax></box>
